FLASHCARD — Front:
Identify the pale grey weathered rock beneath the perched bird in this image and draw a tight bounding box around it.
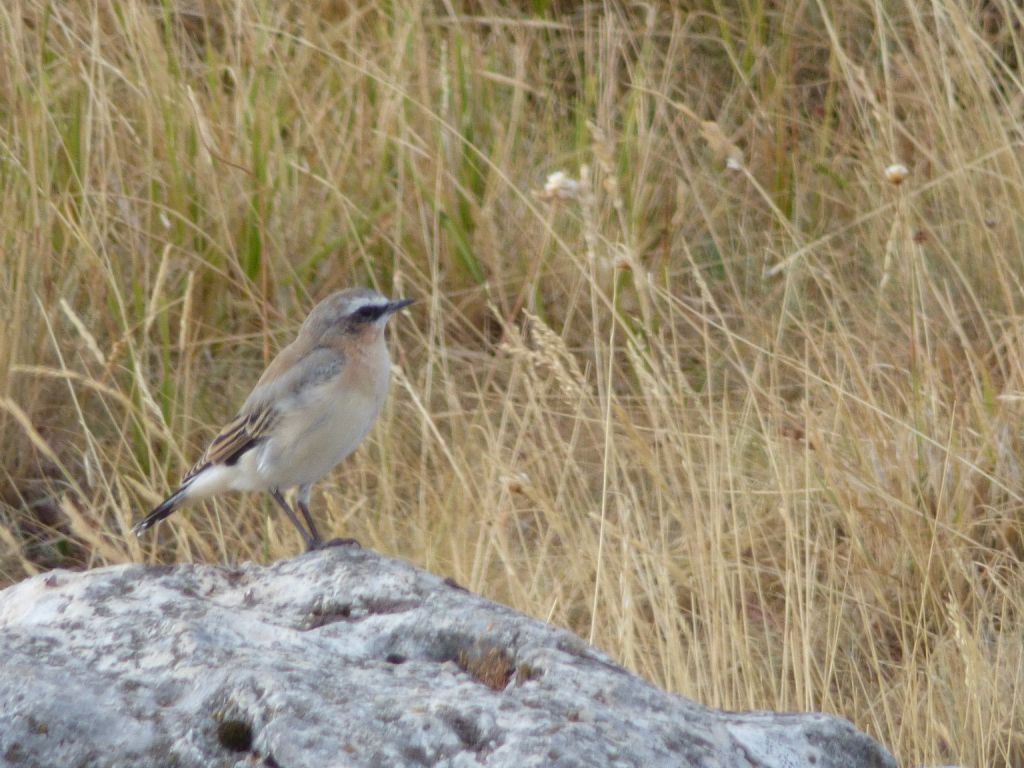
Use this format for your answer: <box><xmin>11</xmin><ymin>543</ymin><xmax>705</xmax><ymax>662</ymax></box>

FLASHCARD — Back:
<box><xmin>0</xmin><ymin>548</ymin><xmax>895</xmax><ymax>768</ymax></box>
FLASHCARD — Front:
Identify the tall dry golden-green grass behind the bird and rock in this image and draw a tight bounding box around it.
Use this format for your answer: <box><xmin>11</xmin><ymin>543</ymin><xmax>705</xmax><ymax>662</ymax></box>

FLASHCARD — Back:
<box><xmin>0</xmin><ymin>0</ymin><xmax>1024</xmax><ymax>766</ymax></box>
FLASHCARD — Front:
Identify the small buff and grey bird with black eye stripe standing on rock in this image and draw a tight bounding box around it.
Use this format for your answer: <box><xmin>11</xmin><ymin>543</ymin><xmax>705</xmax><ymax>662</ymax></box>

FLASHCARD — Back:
<box><xmin>132</xmin><ymin>288</ymin><xmax>413</xmax><ymax>551</ymax></box>
